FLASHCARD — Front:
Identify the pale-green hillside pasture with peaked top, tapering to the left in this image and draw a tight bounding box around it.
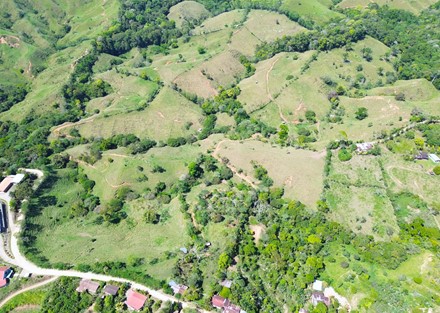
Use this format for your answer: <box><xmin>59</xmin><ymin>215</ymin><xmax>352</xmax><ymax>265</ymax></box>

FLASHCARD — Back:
<box><xmin>64</xmin><ymin>87</ymin><xmax>202</xmax><ymax>140</ymax></box>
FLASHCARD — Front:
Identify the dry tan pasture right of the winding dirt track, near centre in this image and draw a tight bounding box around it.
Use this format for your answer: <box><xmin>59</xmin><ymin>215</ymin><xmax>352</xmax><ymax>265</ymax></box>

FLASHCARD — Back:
<box><xmin>218</xmin><ymin>140</ymin><xmax>324</xmax><ymax>207</ymax></box>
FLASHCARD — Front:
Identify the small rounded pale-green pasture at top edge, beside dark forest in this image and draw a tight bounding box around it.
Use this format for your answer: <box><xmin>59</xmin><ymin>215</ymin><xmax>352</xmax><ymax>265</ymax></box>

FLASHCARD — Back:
<box><xmin>168</xmin><ymin>1</ymin><xmax>209</xmax><ymax>27</ymax></box>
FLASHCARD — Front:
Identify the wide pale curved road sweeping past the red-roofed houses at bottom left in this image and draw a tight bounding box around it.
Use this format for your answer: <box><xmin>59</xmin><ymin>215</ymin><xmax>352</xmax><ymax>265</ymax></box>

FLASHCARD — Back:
<box><xmin>0</xmin><ymin>169</ymin><xmax>209</xmax><ymax>313</ymax></box>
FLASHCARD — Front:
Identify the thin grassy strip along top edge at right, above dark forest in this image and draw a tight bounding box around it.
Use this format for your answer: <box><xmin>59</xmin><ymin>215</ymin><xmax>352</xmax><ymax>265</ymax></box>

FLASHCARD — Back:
<box><xmin>338</xmin><ymin>0</ymin><xmax>437</xmax><ymax>14</ymax></box>
